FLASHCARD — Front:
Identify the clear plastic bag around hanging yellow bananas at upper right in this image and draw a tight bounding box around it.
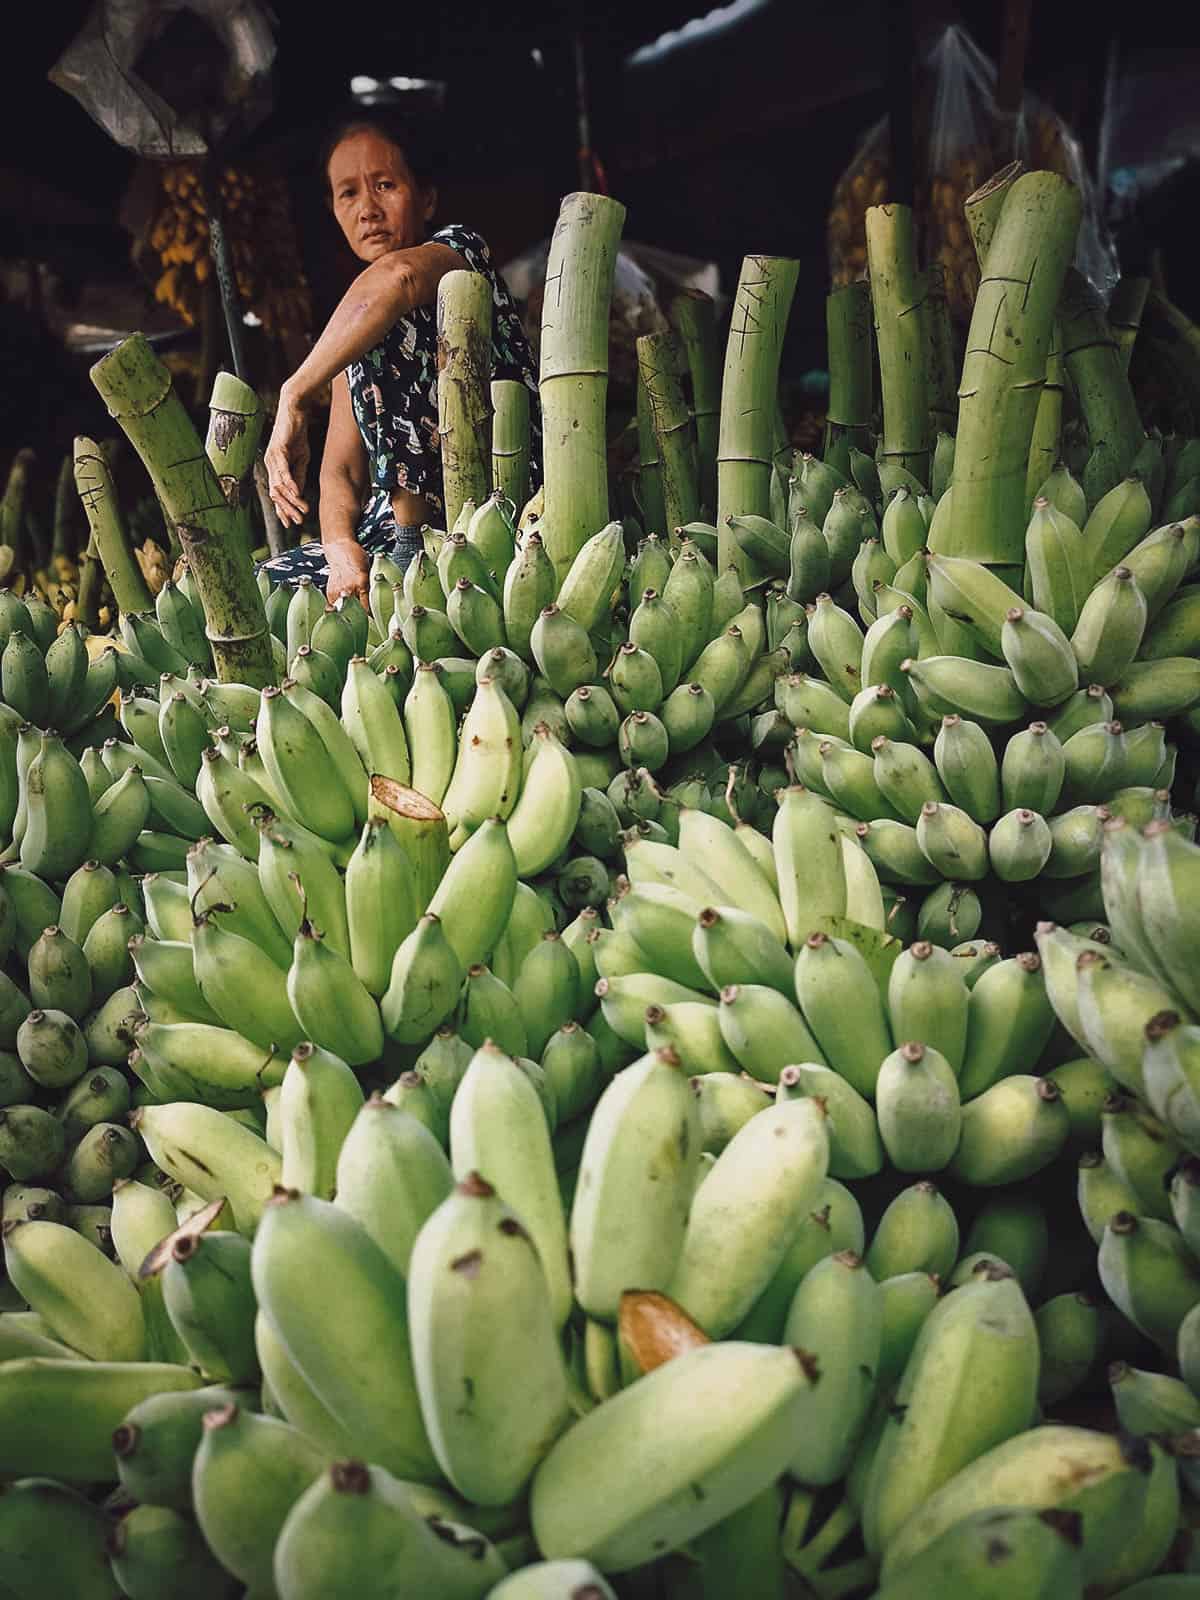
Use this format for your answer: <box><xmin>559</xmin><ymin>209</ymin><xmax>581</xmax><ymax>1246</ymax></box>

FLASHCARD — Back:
<box><xmin>827</xmin><ymin>24</ymin><xmax>1117</xmax><ymax>322</ymax></box>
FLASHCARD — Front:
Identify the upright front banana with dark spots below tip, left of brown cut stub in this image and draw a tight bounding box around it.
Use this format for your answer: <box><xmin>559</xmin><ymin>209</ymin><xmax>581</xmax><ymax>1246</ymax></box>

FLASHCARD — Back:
<box><xmin>408</xmin><ymin>1173</ymin><xmax>570</xmax><ymax>1506</ymax></box>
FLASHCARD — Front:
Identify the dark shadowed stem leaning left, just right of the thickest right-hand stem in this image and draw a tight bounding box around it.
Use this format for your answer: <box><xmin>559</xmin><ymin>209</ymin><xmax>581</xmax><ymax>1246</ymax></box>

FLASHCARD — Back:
<box><xmin>1059</xmin><ymin>267</ymin><xmax>1146</xmax><ymax>501</ymax></box>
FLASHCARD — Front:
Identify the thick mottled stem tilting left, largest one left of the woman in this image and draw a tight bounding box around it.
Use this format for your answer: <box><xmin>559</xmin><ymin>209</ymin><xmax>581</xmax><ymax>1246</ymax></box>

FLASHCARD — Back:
<box><xmin>91</xmin><ymin>333</ymin><xmax>275</xmax><ymax>688</ymax></box>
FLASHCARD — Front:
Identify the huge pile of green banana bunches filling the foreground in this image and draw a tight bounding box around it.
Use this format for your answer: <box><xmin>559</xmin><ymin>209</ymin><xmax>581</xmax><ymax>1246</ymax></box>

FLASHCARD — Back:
<box><xmin>0</xmin><ymin>453</ymin><xmax>1200</xmax><ymax>1600</ymax></box>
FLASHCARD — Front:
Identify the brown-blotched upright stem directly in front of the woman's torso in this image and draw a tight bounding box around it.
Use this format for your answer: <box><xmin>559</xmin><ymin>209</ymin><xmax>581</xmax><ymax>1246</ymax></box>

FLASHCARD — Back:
<box><xmin>437</xmin><ymin>272</ymin><xmax>491</xmax><ymax>528</ymax></box>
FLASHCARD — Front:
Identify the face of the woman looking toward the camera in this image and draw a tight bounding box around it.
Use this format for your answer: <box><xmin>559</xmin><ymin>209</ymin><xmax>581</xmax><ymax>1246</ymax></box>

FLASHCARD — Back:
<box><xmin>328</xmin><ymin>131</ymin><xmax>437</xmax><ymax>261</ymax></box>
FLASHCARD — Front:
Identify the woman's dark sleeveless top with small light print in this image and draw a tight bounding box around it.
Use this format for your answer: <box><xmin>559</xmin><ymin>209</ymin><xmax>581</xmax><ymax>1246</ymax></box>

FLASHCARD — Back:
<box><xmin>346</xmin><ymin>222</ymin><xmax>541</xmax><ymax>544</ymax></box>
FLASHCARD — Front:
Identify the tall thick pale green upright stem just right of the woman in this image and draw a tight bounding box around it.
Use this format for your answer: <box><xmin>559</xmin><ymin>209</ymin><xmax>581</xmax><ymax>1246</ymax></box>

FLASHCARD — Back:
<box><xmin>539</xmin><ymin>192</ymin><xmax>626</xmax><ymax>581</ymax></box>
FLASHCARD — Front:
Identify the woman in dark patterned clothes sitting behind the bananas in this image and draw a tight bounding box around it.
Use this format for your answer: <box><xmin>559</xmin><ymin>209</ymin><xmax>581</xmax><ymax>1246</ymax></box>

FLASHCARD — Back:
<box><xmin>264</xmin><ymin>114</ymin><xmax>541</xmax><ymax>605</ymax></box>
